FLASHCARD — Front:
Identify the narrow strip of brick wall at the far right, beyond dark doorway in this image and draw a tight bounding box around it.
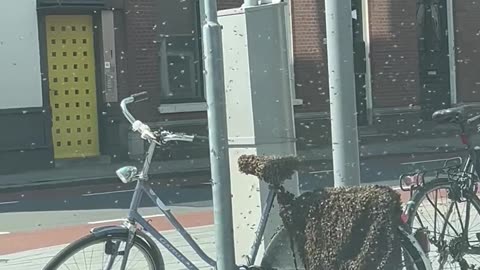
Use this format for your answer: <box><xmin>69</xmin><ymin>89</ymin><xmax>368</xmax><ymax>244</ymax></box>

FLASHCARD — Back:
<box><xmin>454</xmin><ymin>1</ymin><xmax>480</xmax><ymax>102</ymax></box>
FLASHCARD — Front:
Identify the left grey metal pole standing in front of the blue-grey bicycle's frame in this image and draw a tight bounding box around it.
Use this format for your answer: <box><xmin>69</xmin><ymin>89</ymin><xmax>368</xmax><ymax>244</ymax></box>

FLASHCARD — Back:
<box><xmin>202</xmin><ymin>0</ymin><xmax>236</xmax><ymax>270</ymax></box>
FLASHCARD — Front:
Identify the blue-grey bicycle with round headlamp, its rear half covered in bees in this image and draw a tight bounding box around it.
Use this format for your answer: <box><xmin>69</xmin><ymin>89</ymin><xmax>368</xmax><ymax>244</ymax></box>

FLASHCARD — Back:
<box><xmin>44</xmin><ymin>92</ymin><xmax>431</xmax><ymax>270</ymax></box>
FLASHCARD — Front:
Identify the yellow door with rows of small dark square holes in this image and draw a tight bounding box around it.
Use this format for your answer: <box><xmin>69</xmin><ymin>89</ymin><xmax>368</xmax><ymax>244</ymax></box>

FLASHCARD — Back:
<box><xmin>46</xmin><ymin>15</ymin><xmax>99</xmax><ymax>159</ymax></box>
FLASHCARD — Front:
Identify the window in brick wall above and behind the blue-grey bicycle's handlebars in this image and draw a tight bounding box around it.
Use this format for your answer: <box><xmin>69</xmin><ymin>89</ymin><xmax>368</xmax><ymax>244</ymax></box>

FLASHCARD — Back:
<box><xmin>157</xmin><ymin>1</ymin><xmax>205</xmax><ymax>103</ymax></box>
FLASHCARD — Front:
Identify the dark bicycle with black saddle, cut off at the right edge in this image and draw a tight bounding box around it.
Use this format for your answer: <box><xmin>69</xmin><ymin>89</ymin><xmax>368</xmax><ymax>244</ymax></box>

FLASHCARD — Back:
<box><xmin>400</xmin><ymin>106</ymin><xmax>480</xmax><ymax>270</ymax></box>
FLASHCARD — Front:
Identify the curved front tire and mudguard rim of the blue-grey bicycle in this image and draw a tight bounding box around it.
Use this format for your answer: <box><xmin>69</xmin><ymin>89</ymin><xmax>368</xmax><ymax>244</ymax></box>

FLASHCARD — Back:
<box><xmin>43</xmin><ymin>231</ymin><xmax>165</xmax><ymax>270</ymax></box>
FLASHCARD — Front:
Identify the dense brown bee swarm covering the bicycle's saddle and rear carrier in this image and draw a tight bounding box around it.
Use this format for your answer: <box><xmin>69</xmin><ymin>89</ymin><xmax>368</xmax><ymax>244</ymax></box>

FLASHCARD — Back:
<box><xmin>238</xmin><ymin>156</ymin><xmax>402</xmax><ymax>270</ymax></box>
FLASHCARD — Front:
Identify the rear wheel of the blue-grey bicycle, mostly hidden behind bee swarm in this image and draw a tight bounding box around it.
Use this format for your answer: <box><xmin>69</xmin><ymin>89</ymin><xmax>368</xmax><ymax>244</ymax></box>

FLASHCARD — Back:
<box><xmin>261</xmin><ymin>225</ymin><xmax>432</xmax><ymax>270</ymax></box>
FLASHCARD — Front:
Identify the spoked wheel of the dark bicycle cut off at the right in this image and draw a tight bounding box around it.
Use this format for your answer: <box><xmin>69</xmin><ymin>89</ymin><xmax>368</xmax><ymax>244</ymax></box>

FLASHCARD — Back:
<box><xmin>407</xmin><ymin>178</ymin><xmax>480</xmax><ymax>270</ymax></box>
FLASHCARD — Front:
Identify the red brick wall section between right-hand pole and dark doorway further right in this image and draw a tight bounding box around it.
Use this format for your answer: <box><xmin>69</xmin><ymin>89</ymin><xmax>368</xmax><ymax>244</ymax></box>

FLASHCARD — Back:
<box><xmin>369</xmin><ymin>0</ymin><xmax>419</xmax><ymax>108</ymax></box>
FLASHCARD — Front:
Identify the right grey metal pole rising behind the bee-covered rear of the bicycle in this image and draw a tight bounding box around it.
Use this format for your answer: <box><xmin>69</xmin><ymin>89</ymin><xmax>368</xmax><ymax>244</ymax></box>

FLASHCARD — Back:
<box><xmin>325</xmin><ymin>0</ymin><xmax>360</xmax><ymax>187</ymax></box>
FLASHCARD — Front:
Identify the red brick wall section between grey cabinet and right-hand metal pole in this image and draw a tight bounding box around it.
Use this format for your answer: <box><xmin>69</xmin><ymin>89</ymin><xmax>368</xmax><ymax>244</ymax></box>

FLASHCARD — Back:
<box><xmin>291</xmin><ymin>0</ymin><xmax>330</xmax><ymax>112</ymax></box>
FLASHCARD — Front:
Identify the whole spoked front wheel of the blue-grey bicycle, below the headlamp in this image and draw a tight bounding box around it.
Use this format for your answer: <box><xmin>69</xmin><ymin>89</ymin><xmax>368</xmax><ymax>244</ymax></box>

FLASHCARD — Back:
<box><xmin>44</xmin><ymin>232</ymin><xmax>165</xmax><ymax>270</ymax></box>
